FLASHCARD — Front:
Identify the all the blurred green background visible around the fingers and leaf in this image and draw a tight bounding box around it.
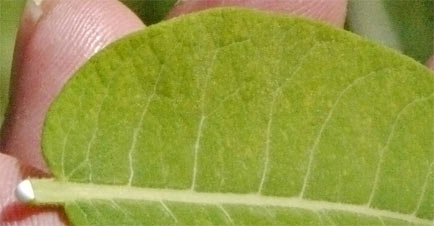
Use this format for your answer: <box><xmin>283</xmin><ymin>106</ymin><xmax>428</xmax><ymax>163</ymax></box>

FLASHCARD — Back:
<box><xmin>0</xmin><ymin>0</ymin><xmax>434</xmax><ymax>127</ymax></box>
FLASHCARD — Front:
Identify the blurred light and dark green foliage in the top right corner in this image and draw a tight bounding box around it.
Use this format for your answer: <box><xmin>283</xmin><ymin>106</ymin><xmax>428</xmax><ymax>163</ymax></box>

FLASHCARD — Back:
<box><xmin>347</xmin><ymin>0</ymin><xmax>434</xmax><ymax>63</ymax></box>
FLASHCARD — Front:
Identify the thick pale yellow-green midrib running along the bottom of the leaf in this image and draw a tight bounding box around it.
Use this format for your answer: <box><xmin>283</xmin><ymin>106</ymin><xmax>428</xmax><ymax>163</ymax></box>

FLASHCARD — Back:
<box><xmin>31</xmin><ymin>179</ymin><xmax>434</xmax><ymax>225</ymax></box>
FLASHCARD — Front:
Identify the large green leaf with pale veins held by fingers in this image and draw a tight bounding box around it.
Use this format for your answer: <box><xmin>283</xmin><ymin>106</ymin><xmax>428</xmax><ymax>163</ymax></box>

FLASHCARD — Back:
<box><xmin>32</xmin><ymin>8</ymin><xmax>434</xmax><ymax>225</ymax></box>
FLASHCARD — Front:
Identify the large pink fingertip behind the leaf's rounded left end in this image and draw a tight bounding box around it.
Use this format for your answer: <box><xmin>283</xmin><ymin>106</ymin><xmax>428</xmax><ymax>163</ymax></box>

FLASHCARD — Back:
<box><xmin>0</xmin><ymin>0</ymin><xmax>144</xmax><ymax>171</ymax></box>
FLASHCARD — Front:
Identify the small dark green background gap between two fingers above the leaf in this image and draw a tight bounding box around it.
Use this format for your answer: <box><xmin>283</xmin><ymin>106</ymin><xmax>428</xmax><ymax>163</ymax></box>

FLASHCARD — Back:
<box><xmin>121</xmin><ymin>0</ymin><xmax>177</xmax><ymax>25</ymax></box>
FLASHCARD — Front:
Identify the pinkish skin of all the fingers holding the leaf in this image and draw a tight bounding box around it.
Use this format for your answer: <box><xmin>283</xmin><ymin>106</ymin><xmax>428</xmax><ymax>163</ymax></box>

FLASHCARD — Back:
<box><xmin>0</xmin><ymin>0</ymin><xmax>434</xmax><ymax>226</ymax></box>
